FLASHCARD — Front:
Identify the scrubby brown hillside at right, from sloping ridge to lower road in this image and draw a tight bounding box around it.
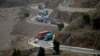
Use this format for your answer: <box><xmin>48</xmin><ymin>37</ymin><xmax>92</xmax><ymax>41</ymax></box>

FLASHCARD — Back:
<box><xmin>57</xmin><ymin>9</ymin><xmax>100</xmax><ymax>50</ymax></box>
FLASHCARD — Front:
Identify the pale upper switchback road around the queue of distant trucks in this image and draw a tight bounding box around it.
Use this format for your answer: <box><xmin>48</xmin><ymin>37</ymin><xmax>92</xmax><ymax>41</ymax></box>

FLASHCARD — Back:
<box><xmin>26</xmin><ymin>6</ymin><xmax>68</xmax><ymax>27</ymax></box>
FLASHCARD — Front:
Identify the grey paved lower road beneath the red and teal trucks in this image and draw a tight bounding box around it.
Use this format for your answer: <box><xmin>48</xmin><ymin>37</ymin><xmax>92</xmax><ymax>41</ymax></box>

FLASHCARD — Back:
<box><xmin>28</xmin><ymin>39</ymin><xmax>100</xmax><ymax>54</ymax></box>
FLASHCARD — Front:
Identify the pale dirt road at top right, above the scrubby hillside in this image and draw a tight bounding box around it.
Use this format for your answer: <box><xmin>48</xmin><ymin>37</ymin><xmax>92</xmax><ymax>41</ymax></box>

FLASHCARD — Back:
<box><xmin>58</xmin><ymin>0</ymin><xmax>96</xmax><ymax>12</ymax></box>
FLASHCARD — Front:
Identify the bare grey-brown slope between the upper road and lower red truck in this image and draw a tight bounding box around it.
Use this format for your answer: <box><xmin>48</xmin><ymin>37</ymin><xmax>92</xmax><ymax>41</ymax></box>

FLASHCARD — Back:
<box><xmin>12</xmin><ymin>22</ymin><xmax>57</xmax><ymax>37</ymax></box>
